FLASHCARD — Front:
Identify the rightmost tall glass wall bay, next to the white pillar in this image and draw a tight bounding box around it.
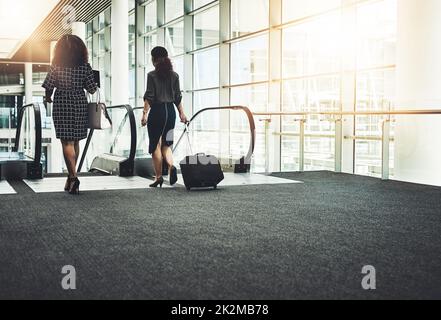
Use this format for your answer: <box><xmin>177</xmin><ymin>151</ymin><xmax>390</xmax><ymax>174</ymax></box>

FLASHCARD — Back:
<box><xmin>355</xmin><ymin>0</ymin><xmax>397</xmax><ymax>176</ymax></box>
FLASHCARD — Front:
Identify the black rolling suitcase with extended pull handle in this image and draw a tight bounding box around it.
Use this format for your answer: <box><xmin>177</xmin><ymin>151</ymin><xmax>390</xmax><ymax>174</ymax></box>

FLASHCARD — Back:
<box><xmin>180</xmin><ymin>123</ymin><xmax>224</xmax><ymax>190</ymax></box>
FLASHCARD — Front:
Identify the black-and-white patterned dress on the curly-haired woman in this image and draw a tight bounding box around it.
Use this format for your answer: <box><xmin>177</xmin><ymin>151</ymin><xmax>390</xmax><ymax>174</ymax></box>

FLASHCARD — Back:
<box><xmin>42</xmin><ymin>63</ymin><xmax>97</xmax><ymax>141</ymax></box>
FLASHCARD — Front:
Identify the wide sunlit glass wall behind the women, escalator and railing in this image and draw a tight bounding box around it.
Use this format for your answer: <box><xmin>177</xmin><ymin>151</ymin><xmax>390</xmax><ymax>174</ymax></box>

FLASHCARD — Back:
<box><xmin>77</xmin><ymin>0</ymin><xmax>397</xmax><ymax>176</ymax></box>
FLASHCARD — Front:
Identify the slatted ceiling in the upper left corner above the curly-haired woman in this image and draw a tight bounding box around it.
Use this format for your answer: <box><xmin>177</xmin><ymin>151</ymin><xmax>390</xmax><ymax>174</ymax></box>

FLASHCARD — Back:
<box><xmin>0</xmin><ymin>0</ymin><xmax>112</xmax><ymax>63</ymax></box>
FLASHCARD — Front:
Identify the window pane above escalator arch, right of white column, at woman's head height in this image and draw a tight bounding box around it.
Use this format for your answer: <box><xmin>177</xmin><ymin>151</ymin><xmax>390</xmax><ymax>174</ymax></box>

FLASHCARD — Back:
<box><xmin>193</xmin><ymin>48</ymin><xmax>219</xmax><ymax>89</ymax></box>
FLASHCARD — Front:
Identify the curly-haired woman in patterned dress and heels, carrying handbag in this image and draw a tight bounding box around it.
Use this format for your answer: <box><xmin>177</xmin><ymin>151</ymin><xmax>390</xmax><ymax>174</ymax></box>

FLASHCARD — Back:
<box><xmin>42</xmin><ymin>35</ymin><xmax>97</xmax><ymax>194</ymax></box>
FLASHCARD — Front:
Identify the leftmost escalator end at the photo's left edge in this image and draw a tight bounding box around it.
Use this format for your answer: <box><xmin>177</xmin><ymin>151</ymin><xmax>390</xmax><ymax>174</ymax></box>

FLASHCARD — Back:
<box><xmin>0</xmin><ymin>103</ymin><xmax>43</xmax><ymax>180</ymax></box>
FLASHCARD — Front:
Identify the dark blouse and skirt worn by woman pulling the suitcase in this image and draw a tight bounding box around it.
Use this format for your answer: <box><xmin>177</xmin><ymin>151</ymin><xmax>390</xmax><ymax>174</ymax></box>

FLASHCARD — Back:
<box><xmin>144</xmin><ymin>71</ymin><xmax>182</xmax><ymax>154</ymax></box>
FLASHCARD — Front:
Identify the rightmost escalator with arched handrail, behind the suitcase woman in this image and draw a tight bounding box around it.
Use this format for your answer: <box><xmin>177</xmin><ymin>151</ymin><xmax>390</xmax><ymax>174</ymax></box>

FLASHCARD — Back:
<box><xmin>134</xmin><ymin>106</ymin><xmax>256</xmax><ymax>177</ymax></box>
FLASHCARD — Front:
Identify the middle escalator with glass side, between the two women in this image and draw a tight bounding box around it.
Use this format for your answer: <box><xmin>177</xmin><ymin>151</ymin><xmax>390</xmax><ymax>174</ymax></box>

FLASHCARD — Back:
<box><xmin>78</xmin><ymin>105</ymin><xmax>137</xmax><ymax>177</ymax></box>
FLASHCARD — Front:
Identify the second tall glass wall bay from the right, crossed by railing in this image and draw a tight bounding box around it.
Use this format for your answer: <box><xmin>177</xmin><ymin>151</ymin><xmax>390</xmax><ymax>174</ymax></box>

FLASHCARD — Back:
<box><xmin>281</xmin><ymin>11</ymin><xmax>342</xmax><ymax>170</ymax></box>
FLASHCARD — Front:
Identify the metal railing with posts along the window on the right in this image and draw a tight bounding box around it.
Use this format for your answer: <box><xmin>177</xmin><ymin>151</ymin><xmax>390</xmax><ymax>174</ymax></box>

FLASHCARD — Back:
<box><xmin>253</xmin><ymin>109</ymin><xmax>441</xmax><ymax>180</ymax></box>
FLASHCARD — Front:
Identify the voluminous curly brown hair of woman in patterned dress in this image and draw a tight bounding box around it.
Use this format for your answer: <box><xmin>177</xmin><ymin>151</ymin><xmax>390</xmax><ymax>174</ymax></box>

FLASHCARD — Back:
<box><xmin>52</xmin><ymin>34</ymin><xmax>89</xmax><ymax>68</ymax></box>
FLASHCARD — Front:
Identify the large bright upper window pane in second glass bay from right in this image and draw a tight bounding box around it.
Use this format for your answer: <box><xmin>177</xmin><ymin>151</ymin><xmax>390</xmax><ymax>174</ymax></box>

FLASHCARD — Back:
<box><xmin>283</xmin><ymin>14</ymin><xmax>341</xmax><ymax>77</ymax></box>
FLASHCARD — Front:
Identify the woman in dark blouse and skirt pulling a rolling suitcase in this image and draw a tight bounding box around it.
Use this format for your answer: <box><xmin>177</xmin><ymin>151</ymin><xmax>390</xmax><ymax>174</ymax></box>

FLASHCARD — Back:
<box><xmin>141</xmin><ymin>47</ymin><xmax>187</xmax><ymax>188</ymax></box>
